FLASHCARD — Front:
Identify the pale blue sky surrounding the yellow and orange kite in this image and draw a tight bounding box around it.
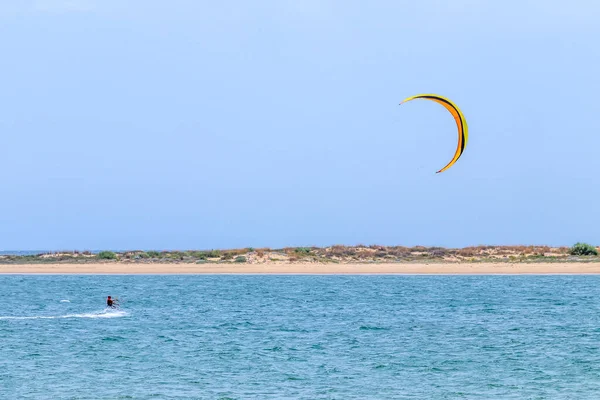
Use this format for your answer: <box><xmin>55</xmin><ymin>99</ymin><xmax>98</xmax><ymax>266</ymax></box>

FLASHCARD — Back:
<box><xmin>0</xmin><ymin>0</ymin><xmax>600</xmax><ymax>250</ymax></box>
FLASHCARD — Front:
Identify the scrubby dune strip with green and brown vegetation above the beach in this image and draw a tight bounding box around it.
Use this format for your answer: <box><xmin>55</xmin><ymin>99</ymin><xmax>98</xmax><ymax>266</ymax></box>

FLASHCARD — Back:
<box><xmin>0</xmin><ymin>243</ymin><xmax>600</xmax><ymax>264</ymax></box>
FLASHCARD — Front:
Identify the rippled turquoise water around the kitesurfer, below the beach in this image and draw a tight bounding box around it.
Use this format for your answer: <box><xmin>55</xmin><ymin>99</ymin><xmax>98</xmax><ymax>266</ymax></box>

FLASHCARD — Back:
<box><xmin>0</xmin><ymin>275</ymin><xmax>600</xmax><ymax>399</ymax></box>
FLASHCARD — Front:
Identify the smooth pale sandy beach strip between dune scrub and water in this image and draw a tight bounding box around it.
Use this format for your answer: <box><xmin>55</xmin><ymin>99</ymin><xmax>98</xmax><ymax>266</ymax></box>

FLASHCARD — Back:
<box><xmin>0</xmin><ymin>262</ymin><xmax>600</xmax><ymax>275</ymax></box>
